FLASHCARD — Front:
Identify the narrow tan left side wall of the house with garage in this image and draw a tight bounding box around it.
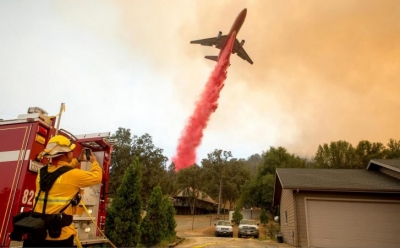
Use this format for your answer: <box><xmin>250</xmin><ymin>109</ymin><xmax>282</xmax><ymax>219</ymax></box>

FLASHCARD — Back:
<box><xmin>280</xmin><ymin>189</ymin><xmax>297</xmax><ymax>246</ymax></box>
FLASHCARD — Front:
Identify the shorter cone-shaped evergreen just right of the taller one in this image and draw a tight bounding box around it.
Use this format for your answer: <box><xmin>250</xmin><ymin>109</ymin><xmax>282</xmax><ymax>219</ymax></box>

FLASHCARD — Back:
<box><xmin>140</xmin><ymin>186</ymin><xmax>169</xmax><ymax>247</ymax></box>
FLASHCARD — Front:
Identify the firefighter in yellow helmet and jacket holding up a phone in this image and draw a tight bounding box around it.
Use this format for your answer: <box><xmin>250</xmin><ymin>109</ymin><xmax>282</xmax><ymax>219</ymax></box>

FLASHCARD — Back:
<box><xmin>23</xmin><ymin>135</ymin><xmax>102</xmax><ymax>247</ymax></box>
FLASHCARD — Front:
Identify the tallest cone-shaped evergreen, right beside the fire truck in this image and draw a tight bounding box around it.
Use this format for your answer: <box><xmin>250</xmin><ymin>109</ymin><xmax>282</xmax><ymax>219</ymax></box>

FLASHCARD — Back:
<box><xmin>106</xmin><ymin>160</ymin><xmax>142</xmax><ymax>247</ymax></box>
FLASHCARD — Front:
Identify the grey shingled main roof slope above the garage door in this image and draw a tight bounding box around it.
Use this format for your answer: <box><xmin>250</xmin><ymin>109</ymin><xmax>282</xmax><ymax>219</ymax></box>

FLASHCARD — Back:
<box><xmin>276</xmin><ymin>168</ymin><xmax>400</xmax><ymax>193</ymax></box>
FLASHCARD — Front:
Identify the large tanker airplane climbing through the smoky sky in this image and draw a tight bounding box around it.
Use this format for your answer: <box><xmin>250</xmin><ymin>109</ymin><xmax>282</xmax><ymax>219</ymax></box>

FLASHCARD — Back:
<box><xmin>190</xmin><ymin>9</ymin><xmax>253</xmax><ymax>64</ymax></box>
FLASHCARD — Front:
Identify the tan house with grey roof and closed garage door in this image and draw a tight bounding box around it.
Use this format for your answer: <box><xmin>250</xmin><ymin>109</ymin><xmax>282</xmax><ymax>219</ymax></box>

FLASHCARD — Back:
<box><xmin>273</xmin><ymin>159</ymin><xmax>400</xmax><ymax>247</ymax></box>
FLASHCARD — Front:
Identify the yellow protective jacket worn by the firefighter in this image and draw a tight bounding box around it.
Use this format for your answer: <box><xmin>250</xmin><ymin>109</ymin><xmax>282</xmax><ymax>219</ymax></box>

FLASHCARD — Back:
<box><xmin>34</xmin><ymin>159</ymin><xmax>102</xmax><ymax>240</ymax></box>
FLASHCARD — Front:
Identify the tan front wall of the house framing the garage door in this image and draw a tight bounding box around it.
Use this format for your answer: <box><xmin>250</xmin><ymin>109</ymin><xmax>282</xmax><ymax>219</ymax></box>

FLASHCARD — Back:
<box><xmin>294</xmin><ymin>190</ymin><xmax>400</xmax><ymax>247</ymax></box>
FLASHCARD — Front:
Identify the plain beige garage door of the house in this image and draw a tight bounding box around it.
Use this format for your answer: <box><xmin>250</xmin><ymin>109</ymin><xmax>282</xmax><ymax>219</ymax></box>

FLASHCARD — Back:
<box><xmin>306</xmin><ymin>199</ymin><xmax>400</xmax><ymax>248</ymax></box>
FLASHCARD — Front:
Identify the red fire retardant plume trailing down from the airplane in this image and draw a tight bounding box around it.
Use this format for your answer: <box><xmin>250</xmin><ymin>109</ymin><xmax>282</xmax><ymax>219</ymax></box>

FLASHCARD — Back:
<box><xmin>172</xmin><ymin>33</ymin><xmax>236</xmax><ymax>171</ymax></box>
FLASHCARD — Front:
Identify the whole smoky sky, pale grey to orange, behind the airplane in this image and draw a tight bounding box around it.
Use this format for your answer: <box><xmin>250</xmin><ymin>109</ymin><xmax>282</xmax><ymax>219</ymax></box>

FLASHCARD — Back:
<box><xmin>0</xmin><ymin>0</ymin><xmax>400</xmax><ymax>162</ymax></box>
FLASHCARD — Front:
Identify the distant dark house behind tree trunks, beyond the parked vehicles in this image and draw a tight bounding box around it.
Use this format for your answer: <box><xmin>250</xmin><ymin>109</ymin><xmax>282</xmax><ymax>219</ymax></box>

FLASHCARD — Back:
<box><xmin>173</xmin><ymin>188</ymin><xmax>216</xmax><ymax>215</ymax></box>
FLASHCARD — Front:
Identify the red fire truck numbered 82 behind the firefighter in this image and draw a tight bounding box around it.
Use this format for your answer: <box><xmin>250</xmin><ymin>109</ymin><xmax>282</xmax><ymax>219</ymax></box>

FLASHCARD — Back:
<box><xmin>0</xmin><ymin>107</ymin><xmax>113</xmax><ymax>247</ymax></box>
